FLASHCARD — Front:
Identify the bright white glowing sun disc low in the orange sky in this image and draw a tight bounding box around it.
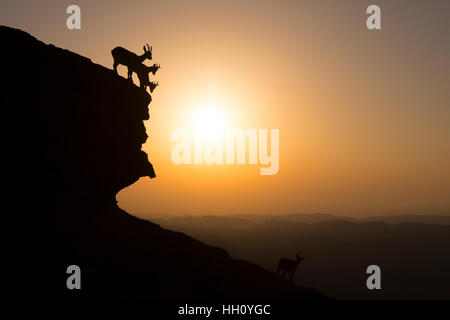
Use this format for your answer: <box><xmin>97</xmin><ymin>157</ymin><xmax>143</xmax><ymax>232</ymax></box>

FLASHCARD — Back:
<box><xmin>191</xmin><ymin>100</ymin><xmax>229</xmax><ymax>140</ymax></box>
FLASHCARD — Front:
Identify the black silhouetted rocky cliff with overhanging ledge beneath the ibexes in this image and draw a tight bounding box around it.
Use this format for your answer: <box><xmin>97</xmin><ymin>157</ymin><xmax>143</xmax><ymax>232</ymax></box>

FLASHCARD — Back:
<box><xmin>0</xmin><ymin>26</ymin><xmax>323</xmax><ymax>299</ymax></box>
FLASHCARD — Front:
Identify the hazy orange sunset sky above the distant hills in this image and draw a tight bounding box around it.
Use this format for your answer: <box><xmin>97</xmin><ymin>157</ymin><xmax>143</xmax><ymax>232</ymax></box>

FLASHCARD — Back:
<box><xmin>0</xmin><ymin>0</ymin><xmax>450</xmax><ymax>216</ymax></box>
